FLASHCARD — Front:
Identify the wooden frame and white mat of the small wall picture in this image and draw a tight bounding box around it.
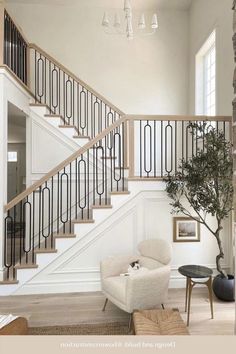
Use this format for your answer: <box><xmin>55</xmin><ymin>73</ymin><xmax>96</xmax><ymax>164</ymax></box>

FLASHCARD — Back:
<box><xmin>173</xmin><ymin>216</ymin><xmax>201</xmax><ymax>243</ymax></box>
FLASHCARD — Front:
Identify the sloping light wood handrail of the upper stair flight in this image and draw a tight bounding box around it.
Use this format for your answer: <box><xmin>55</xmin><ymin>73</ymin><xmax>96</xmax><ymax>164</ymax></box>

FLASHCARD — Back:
<box><xmin>29</xmin><ymin>43</ymin><xmax>125</xmax><ymax>116</ymax></box>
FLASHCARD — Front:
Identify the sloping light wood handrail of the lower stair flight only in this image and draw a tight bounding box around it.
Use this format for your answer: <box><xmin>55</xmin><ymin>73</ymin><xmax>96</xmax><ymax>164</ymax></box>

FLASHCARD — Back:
<box><xmin>4</xmin><ymin>116</ymin><xmax>126</xmax><ymax>212</ymax></box>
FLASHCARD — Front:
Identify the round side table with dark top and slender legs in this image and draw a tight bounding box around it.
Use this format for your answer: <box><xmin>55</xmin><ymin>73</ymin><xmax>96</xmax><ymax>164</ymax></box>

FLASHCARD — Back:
<box><xmin>178</xmin><ymin>265</ymin><xmax>214</xmax><ymax>326</ymax></box>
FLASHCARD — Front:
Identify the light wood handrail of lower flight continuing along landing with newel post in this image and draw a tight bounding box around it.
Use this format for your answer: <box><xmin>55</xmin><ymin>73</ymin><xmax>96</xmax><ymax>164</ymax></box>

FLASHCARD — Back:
<box><xmin>4</xmin><ymin>115</ymin><xmax>231</xmax><ymax>212</ymax></box>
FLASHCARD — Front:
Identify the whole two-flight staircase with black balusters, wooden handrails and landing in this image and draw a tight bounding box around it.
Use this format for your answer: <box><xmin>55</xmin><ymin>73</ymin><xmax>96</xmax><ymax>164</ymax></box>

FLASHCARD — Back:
<box><xmin>0</xmin><ymin>11</ymin><xmax>230</xmax><ymax>295</ymax></box>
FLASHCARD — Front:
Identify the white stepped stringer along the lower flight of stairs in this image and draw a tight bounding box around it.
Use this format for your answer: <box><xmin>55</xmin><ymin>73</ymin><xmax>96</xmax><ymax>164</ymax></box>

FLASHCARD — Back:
<box><xmin>0</xmin><ymin>181</ymin><xmax>164</xmax><ymax>296</ymax></box>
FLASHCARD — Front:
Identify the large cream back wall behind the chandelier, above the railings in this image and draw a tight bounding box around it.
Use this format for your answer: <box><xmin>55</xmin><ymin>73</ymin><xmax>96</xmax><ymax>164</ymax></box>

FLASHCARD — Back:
<box><xmin>7</xmin><ymin>1</ymin><xmax>188</xmax><ymax>114</ymax></box>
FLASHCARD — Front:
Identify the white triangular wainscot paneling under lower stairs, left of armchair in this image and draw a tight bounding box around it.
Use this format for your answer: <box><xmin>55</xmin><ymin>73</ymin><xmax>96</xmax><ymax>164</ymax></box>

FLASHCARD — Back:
<box><xmin>17</xmin><ymin>206</ymin><xmax>137</xmax><ymax>294</ymax></box>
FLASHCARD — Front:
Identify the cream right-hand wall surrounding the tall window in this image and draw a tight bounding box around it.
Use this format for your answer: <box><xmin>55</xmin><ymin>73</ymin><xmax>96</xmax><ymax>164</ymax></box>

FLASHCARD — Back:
<box><xmin>189</xmin><ymin>0</ymin><xmax>234</xmax><ymax>115</ymax></box>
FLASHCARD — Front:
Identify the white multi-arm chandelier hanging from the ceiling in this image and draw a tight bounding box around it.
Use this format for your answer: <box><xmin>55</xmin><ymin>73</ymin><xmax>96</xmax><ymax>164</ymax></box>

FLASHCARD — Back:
<box><xmin>102</xmin><ymin>0</ymin><xmax>158</xmax><ymax>39</ymax></box>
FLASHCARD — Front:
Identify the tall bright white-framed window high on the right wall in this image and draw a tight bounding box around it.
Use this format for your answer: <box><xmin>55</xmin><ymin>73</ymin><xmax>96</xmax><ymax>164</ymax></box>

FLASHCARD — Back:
<box><xmin>195</xmin><ymin>31</ymin><xmax>216</xmax><ymax>116</ymax></box>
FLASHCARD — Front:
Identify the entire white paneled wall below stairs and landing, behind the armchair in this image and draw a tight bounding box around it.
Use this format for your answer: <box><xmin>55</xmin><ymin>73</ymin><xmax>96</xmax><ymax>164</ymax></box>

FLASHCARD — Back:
<box><xmin>13</xmin><ymin>189</ymin><xmax>230</xmax><ymax>294</ymax></box>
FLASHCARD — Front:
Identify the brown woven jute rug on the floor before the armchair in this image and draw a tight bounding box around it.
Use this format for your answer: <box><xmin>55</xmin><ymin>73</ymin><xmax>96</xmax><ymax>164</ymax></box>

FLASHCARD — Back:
<box><xmin>28</xmin><ymin>322</ymin><xmax>132</xmax><ymax>336</ymax></box>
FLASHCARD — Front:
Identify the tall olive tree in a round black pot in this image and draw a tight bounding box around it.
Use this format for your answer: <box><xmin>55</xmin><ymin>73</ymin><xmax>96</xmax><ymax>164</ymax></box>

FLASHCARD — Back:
<box><xmin>165</xmin><ymin>124</ymin><xmax>234</xmax><ymax>301</ymax></box>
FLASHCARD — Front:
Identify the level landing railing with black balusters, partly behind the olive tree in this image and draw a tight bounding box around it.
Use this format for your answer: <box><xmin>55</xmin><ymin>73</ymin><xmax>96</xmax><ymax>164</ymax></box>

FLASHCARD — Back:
<box><xmin>127</xmin><ymin>115</ymin><xmax>231</xmax><ymax>179</ymax></box>
